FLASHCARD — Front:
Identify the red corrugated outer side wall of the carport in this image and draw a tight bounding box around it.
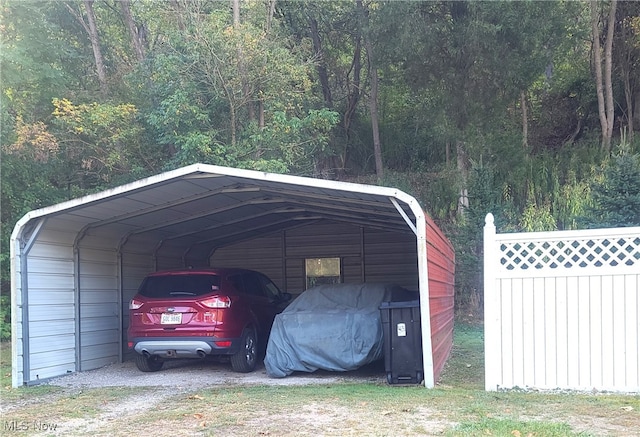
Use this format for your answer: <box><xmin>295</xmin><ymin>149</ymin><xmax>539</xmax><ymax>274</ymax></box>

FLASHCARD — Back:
<box><xmin>426</xmin><ymin>216</ymin><xmax>455</xmax><ymax>381</ymax></box>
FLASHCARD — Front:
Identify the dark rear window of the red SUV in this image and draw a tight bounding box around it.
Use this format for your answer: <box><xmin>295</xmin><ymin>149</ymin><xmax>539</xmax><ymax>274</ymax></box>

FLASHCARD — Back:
<box><xmin>138</xmin><ymin>274</ymin><xmax>220</xmax><ymax>298</ymax></box>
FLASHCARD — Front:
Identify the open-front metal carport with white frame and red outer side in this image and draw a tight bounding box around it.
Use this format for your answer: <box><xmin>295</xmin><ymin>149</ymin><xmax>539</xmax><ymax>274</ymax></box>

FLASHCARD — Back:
<box><xmin>11</xmin><ymin>164</ymin><xmax>454</xmax><ymax>387</ymax></box>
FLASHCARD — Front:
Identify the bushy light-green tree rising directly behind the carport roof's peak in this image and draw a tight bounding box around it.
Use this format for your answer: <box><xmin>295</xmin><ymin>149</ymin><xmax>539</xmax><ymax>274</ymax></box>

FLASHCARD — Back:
<box><xmin>139</xmin><ymin>2</ymin><xmax>335</xmax><ymax>173</ymax></box>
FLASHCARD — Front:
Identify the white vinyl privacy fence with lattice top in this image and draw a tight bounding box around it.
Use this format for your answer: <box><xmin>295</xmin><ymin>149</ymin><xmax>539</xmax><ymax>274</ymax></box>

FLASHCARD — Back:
<box><xmin>484</xmin><ymin>214</ymin><xmax>640</xmax><ymax>393</ymax></box>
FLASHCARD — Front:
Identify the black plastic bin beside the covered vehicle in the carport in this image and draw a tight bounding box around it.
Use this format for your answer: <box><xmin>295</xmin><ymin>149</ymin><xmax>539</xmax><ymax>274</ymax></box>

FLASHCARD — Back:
<box><xmin>380</xmin><ymin>300</ymin><xmax>424</xmax><ymax>384</ymax></box>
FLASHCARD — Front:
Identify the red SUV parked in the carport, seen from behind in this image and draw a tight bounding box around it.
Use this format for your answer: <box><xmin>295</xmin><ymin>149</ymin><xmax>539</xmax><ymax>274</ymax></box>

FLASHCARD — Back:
<box><xmin>127</xmin><ymin>269</ymin><xmax>291</xmax><ymax>373</ymax></box>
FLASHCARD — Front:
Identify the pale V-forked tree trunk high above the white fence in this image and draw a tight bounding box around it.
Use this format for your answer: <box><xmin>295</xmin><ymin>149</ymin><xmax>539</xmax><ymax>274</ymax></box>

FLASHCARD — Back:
<box><xmin>591</xmin><ymin>0</ymin><xmax>617</xmax><ymax>152</ymax></box>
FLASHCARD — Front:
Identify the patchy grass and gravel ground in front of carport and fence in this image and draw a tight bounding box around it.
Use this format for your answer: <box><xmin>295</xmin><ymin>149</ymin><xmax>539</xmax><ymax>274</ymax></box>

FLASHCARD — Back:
<box><xmin>0</xmin><ymin>323</ymin><xmax>640</xmax><ymax>437</ymax></box>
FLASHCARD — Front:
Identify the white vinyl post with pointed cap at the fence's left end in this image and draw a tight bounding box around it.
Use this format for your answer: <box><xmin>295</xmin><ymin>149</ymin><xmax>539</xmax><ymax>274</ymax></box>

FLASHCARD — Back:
<box><xmin>483</xmin><ymin>213</ymin><xmax>502</xmax><ymax>391</ymax></box>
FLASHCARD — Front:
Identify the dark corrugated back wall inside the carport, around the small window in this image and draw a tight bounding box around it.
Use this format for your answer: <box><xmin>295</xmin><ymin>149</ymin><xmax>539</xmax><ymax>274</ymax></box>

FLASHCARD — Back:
<box><xmin>210</xmin><ymin>222</ymin><xmax>418</xmax><ymax>294</ymax></box>
